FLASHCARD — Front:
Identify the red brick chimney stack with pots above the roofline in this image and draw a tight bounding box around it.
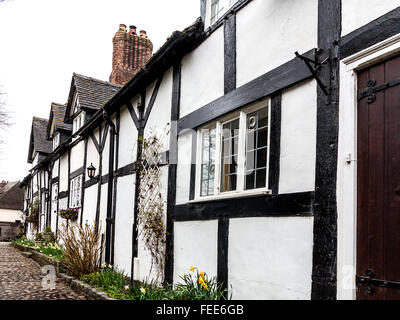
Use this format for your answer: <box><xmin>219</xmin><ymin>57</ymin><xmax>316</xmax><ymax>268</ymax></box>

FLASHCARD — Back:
<box><xmin>110</xmin><ymin>24</ymin><xmax>153</xmax><ymax>85</ymax></box>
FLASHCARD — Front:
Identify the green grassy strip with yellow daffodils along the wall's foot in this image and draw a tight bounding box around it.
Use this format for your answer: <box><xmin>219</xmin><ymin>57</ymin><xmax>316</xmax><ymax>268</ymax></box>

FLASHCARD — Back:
<box><xmin>81</xmin><ymin>266</ymin><xmax>227</xmax><ymax>300</ymax></box>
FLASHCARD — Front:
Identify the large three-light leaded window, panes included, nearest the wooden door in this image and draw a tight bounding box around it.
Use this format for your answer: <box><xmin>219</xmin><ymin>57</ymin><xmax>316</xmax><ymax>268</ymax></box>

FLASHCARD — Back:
<box><xmin>196</xmin><ymin>101</ymin><xmax>270</xmax><ymax>198</ymax></box>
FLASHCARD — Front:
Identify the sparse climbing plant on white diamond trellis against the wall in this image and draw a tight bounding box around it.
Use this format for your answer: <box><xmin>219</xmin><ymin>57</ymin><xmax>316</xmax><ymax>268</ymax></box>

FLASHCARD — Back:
<box><xmin>137</xmin><ymin>130</ymin><xmax>168</xmax><ymax>282</ymax></box>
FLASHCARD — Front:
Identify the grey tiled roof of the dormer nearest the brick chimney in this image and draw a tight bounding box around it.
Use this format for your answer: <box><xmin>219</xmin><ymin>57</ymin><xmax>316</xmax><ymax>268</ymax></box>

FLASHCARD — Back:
<box><xmin>73</xmin><ymin>73</ymin><xmax>122</xmax><ymax>110</ymax></box>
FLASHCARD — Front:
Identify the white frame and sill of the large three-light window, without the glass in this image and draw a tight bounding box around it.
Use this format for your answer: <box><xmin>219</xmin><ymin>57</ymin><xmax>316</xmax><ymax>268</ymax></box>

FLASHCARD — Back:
<box><xmin>194</xmin><ymin>98</ymin><xmax>272</xmax><ymax>202</ymax></box>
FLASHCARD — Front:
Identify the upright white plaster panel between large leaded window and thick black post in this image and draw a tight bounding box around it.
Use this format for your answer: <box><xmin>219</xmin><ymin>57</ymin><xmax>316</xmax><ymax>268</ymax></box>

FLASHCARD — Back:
<box><xmin>279</xmin><ymin>81</ymin><xmax>317</xmax><ymax>193</ymax></box>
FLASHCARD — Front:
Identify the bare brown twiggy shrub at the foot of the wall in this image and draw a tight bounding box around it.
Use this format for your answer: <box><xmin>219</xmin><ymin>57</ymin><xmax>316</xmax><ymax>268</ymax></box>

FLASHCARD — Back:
<box><xmin>60</xmin><ymin>223</ymin><xmax>101</xmax><ymax>278</ymax></box>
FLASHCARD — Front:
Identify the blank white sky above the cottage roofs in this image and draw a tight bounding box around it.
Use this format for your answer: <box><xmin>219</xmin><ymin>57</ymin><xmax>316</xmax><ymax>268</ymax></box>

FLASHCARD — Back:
<box><xmin>0</xmin><ymin>0</ymin><xmax>200</xmax><ymax>180</ymax></box>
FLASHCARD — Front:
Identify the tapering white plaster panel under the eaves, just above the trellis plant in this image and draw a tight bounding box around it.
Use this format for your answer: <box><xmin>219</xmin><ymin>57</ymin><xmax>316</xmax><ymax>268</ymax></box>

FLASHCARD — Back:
<box><xmin>144</xmin><ymin>69</ymin><xmax>172</xmax><ymax>152</ymax></box>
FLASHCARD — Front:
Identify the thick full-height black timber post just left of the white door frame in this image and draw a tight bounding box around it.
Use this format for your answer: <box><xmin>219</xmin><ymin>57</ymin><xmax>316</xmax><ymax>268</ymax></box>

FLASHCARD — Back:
<box><xmin>311</xmin><ymin>0</ymin><xmax>342</xmax><ymax>300</ymax></box>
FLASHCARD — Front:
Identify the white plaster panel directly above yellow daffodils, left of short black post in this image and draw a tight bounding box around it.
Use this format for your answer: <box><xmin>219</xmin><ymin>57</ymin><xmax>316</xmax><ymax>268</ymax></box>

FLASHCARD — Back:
<box><xmin>174</xmin><ymin>220</ymin><xmax>218</xmax><ymax>283</ymax></box>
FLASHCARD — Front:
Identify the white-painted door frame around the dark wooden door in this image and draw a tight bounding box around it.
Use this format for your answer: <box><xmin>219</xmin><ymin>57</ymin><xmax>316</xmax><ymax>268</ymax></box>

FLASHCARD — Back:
<box><xmin>337</xmin><ymin>35</ymin><xmax>400</xmax><ymax>300</ymax></box>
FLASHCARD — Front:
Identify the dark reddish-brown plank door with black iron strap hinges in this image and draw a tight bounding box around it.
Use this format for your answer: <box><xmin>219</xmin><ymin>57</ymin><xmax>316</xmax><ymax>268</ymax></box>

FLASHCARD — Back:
<box><xmin>357</xmin><ymin>57</ymin><xmax>400</xmax><ymax>300</ymax></box>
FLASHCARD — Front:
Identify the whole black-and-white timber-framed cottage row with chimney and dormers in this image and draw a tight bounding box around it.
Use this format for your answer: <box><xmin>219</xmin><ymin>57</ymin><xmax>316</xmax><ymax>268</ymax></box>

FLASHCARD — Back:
<box><xmin>23</xmin><ymin>0</ymin><xmax>400</xmax><ymax>299</ymax></box>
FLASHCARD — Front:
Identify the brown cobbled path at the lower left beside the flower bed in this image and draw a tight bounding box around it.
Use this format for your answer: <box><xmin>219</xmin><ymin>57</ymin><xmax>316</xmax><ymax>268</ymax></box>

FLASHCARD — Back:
<box><xmin>0</xmin><ymin>242</ymin><xmax>86</xmax><ymax>300</ymax></box>
